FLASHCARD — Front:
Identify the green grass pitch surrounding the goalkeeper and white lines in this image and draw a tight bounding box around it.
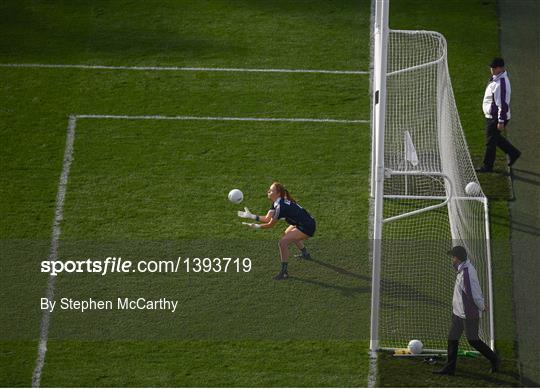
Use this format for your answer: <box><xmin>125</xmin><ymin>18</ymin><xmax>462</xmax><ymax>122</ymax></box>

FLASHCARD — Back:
<box><xmin>0</xmin><ymin>0</ymin><xmax>515</xmax><ymax>386</ymax></box>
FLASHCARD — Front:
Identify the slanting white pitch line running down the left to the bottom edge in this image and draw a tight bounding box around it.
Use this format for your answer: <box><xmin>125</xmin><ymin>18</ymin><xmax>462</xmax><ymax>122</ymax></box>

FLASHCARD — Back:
<box><xmin>32</xmin><ymin>116</ymin><xmax>77</xmax><ymax>388</ymax></box>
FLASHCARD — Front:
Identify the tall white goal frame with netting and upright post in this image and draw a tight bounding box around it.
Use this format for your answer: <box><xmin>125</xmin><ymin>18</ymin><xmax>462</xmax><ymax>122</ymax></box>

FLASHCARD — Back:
<box><xmin>370</xmin><ymin>0</ymin><xmax>494</xmax><ymax>352</ymax></box>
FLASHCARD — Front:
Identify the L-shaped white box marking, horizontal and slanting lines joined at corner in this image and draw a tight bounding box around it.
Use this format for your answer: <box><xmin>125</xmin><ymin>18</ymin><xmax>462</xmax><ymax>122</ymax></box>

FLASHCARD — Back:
<box><xmin>32</xmin><ymin>110</ymin><xmax>369</xmax><ymax>388</ymax></box>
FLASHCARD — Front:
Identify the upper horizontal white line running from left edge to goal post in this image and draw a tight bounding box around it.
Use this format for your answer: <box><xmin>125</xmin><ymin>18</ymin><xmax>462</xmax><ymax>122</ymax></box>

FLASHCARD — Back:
<box><xmin>0</xmin><ymin>63</ymin><xmax>369</xmax><ymax>74</ymax></box>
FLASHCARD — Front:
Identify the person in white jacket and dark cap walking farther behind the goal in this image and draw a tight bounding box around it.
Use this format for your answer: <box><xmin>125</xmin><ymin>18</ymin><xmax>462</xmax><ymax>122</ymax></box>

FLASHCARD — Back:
<box><xmin>476</xmin><ymin>58</ymin><xmax>521</xmax><ymax>173</ymax></box>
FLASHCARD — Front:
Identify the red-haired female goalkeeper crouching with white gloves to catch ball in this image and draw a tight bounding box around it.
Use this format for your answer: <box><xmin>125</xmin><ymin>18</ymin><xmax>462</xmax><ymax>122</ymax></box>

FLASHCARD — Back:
<box><xmin>238</xmin><ymin>182</ymin><xmax>316</xmax><ymax>280</ymax></box>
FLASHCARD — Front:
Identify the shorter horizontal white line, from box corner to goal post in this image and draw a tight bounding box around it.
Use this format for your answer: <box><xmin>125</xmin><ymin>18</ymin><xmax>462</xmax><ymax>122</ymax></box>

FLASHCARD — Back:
<box><xmin>75</xmin><ymin>115</ymin><xmax>369</xmax><ymax>123</ymax></box>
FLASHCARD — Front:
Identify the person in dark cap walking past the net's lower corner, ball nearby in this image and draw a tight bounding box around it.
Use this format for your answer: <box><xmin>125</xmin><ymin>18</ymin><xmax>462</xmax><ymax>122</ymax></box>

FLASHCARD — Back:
<box><xmin>433</xmin><ymin>246</ymin><xmax>500</xmax><ymax>375</ymax></box>
